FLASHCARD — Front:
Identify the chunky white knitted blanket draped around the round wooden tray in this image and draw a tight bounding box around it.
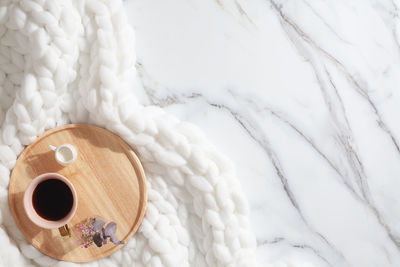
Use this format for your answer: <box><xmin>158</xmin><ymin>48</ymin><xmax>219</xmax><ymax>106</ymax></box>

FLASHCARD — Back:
<box><xmin>0</xmin><ymin>0</ymin><xmax>298</xmax><ymax>267</ymax></box>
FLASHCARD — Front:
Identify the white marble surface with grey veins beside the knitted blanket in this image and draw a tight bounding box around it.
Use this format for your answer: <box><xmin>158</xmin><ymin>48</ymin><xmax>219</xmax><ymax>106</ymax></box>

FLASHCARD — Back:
<box><xmin>124</xmin><ymin>0</ymin><xmax>400</xmax><ymax>267</ymax></box>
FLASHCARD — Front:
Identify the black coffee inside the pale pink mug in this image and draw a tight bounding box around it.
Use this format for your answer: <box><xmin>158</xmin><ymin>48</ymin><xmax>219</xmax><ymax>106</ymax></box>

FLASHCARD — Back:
<box><xmin>32</xmin><ymin>178</ymin><xmax>73</xmax><ymax>221</ymax></box>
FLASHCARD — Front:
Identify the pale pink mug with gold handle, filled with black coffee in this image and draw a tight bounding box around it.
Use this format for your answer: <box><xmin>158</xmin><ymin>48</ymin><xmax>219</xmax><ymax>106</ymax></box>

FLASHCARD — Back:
<box><xmin>24</xmin><ymin>173</ymin><xmax>78</xmax><ymax>236</ymax></box>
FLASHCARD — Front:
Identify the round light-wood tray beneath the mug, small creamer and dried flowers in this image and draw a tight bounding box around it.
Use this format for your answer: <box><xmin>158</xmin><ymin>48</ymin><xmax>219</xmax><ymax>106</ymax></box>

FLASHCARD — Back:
<box><xmin>8</xmin><ymin>124</ymin><xmax>147</xmax><ymax>262</ymax></box>
